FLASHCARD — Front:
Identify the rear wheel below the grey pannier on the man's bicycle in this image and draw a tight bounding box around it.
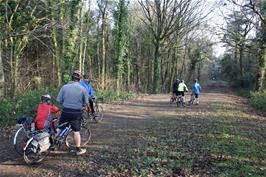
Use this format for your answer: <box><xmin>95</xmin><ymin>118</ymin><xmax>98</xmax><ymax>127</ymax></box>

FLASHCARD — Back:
<box><xmin>23</xmin><ymin>138</ymin><xmax>50</xmax><ymax>164</ymax></box>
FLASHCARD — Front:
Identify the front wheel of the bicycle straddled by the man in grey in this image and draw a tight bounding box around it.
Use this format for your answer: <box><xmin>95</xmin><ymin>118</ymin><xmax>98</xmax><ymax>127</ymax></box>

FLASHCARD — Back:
<box><xmin>66</xmin><ymin>125</ymin><xmax>91</xmax><ymax>148</ymax></box>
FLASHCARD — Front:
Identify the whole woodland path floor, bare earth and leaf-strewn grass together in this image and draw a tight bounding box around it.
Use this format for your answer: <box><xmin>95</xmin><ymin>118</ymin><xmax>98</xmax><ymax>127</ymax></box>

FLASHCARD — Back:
<box><xmin>0</xmin><ymin>85</ymin><xmax>266</xmax><ymax>177</ymax></box>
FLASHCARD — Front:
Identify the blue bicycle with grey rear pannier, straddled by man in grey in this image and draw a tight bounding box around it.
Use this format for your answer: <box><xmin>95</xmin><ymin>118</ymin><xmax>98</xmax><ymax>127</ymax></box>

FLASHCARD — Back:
<box><xmin>23</xmin><ymin>119</ymin><xmax>91</xmax><ymax>164</ymax></box>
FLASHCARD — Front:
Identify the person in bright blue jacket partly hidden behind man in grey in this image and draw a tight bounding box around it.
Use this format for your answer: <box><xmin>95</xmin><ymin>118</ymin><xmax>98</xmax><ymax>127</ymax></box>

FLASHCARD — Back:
<box><xmin>80</xmin><ymin>74</ymin><xmax>95</xmax><ymax>114</ymax></box>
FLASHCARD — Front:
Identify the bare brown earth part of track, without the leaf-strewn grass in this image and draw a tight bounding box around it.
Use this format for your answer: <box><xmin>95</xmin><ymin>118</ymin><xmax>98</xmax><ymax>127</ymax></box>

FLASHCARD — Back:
<box><xmin>0</xmin><ymin>85</ymin><xmax>266</xmax><ymax>177</ymax></box>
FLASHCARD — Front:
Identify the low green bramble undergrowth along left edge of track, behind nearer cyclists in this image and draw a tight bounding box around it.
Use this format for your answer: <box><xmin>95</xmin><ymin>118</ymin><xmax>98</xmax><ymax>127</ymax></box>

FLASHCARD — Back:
<box><xmin>0</xmin><ymin>88</ymin><xmax>135</xmax><ymax>127</ymax></box>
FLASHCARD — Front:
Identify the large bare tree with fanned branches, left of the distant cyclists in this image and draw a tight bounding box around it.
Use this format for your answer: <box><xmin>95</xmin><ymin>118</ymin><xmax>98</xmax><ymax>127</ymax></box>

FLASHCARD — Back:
<box><xmin>138</xmin><ymin>0</ymin><xmax>207</xmax><ymax>93</ymax></box>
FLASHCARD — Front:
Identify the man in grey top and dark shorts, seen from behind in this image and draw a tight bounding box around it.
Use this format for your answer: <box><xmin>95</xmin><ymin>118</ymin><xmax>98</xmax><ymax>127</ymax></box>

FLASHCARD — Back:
<box><xmin>56</xmin><ymin>71</ymin><xmax>88</xmax><ymax>155</ymax></box>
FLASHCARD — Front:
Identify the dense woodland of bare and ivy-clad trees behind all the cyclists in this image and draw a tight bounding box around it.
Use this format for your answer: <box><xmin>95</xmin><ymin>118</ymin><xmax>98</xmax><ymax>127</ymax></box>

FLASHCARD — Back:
<box><xmin>0</xmin><ymin>0</ymin><xmax>266</xmax><ymax>97</ymax></box>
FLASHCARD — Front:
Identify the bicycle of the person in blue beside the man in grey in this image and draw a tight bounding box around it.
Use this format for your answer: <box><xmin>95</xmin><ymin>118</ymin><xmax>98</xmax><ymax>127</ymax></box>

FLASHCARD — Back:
<box><xmin>82</xmin><ymin>97</ymin><xmax>103</xmax><ymax>124</ymax></box>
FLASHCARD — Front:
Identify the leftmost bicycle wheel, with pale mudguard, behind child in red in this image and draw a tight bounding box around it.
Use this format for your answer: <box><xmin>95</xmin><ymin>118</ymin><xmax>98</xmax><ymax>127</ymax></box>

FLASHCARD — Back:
<box><xmin>13</xmin><ymin>127</ymin><xmax>29</xmax><ymax>155</ymax></box>
